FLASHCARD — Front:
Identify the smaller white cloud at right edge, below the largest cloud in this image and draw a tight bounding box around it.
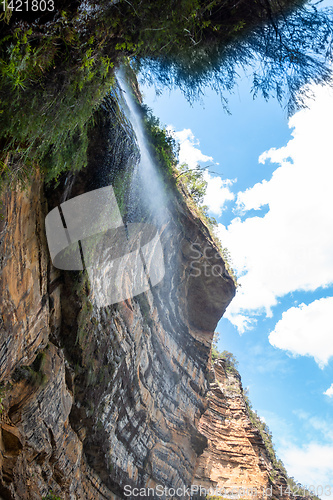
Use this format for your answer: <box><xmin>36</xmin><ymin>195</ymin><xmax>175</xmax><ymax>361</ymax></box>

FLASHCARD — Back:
<box><xmin>269</xmin><ymin>297</ymin><xmax>333</xmax><ymax>368</ymax></box>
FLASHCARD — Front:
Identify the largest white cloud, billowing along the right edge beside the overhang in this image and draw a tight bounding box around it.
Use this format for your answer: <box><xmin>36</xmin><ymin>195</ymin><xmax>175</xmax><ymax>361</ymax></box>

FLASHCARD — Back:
<box><xmin>219</xmin><ymin>83</ymin><xmax>333</xmax><ymax>331</ymax></box>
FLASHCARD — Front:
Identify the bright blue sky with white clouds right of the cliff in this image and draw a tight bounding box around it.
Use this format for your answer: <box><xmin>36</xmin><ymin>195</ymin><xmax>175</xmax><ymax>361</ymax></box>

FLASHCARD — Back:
<box><xmin>142</xmin><ymin>66</ymin><xmax>333</xmax><ymax>492</ymax></box>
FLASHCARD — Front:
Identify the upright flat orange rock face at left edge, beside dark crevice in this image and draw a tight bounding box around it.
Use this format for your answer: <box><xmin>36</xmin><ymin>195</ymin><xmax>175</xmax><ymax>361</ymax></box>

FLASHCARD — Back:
<box><xmin>0</xmin><ymin>175</ymin><xmax>49</xmax><ymax>378</ymax></box>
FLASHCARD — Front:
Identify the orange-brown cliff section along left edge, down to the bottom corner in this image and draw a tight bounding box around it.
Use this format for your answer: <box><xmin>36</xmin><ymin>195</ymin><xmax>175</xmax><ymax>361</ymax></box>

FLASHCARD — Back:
<box><xmin>0</xmin><ymin>177</ymin><xmax>101</xmax><ymax>499</ymax></box>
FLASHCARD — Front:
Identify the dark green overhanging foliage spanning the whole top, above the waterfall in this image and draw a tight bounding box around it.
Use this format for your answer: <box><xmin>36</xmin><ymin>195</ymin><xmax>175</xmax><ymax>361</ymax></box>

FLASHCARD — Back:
<box><xmin>0</xmin><ymin>0</ymin><xmax>333</xmax><ymax>188</ymax></box>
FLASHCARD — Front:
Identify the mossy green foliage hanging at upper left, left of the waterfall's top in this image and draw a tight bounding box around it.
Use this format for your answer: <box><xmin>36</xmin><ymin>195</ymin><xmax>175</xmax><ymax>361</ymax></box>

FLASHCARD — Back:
<box><xmin>0</xmin><ymin>17</ymin><xmax>114</xmax><ymax>186</ymax></box>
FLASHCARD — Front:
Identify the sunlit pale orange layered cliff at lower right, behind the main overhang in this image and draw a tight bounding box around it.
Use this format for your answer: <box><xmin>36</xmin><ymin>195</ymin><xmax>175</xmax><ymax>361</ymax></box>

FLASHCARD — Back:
<box><xmin>195</xmin><ymin>359</ymin><xmax>288</xmax><ymax>499</ymax></box>
